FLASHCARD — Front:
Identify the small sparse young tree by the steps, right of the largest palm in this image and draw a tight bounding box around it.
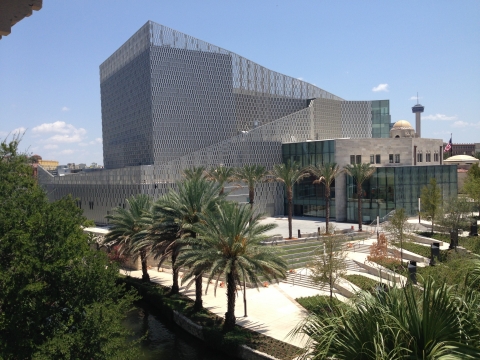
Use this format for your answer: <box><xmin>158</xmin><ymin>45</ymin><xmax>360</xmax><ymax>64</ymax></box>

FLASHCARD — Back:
<box><xmin>308</xmin><ymin>236</ymin><xmax>347</xmax><ymax>302</ymax></box>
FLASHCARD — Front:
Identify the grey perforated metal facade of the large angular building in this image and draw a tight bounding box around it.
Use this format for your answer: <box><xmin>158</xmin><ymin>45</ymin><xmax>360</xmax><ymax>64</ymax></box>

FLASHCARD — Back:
<box><xmin>39</xmin><ymin>21</ymin><xmax>394</xmax><ymax>223</ymax></box>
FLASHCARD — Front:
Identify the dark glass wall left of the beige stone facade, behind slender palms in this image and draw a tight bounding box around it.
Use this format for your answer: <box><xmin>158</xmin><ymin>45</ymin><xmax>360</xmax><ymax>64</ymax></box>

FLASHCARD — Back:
<box><xmin>282</xmin><ymin>140</ymin><xmax>335</xmax><ymax>217</ymax></box>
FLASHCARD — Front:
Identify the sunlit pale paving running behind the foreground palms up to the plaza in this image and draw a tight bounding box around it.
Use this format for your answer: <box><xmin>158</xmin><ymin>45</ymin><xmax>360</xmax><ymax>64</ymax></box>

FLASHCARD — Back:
<box><xmin>126</xmin><ymin>217</ymin><xmax>436</xmax><ymax>347</ymax></box>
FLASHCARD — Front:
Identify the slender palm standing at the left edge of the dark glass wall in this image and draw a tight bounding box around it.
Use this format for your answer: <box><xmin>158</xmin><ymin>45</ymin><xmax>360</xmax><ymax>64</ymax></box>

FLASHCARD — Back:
<box><xmin>270</xmin><ymin>160</ymin><xmax>308</xmax><ymax>239</ymax></box>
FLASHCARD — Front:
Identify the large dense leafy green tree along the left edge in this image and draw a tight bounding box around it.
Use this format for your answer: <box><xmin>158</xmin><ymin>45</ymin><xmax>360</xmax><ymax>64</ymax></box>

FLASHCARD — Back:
<box><xmin>0</xmin><ymin>138</ymin><xmax>137</xmax><ymax>359</ymax></box>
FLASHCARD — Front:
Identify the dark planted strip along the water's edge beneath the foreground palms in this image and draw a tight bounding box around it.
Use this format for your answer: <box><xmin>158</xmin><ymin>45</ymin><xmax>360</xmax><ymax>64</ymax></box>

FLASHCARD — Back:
<box><xmin>118</xmin><ymin>276</ymin><xmax>301</xmax><ymax>360</ymax></box>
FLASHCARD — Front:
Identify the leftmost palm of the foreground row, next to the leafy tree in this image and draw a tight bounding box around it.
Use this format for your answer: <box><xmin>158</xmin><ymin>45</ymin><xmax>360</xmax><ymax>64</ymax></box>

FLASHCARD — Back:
<box><xmin>104</xmin><ymin>194</ymin><xmax>152</xmax><ymax>281</ymax></box>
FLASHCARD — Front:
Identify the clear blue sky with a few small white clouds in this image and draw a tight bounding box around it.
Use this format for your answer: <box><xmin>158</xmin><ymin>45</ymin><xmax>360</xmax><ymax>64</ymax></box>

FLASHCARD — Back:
<box><xmin>0</xmin><ymin>0</ymin><xmax>480</xmax><ymax>164</ymax></box>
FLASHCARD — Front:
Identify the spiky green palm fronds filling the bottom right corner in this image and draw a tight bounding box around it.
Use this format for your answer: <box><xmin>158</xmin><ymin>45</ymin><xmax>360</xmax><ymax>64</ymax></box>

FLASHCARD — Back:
<box><xmin>292</xmin><ymin>274</ymin><xmax>480</xmax><ymax>360</ymax></box>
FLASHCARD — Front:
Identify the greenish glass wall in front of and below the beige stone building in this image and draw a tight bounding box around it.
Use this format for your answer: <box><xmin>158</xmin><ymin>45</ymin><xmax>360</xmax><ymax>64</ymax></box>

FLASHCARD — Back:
<box><xmin>347</xmin><ymin>165</ymin><xmax>458</xmax><ymax>223</ymax></box>
